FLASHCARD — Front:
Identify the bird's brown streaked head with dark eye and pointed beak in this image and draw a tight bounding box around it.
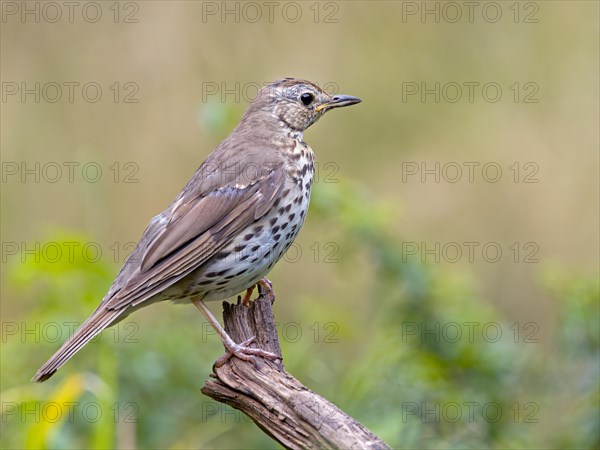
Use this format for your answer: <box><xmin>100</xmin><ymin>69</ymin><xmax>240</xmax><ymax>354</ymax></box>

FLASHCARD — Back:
<box><xmin>248</xmin><ymin>78</ymin><xmax>361</xmax><ymax>132</ymax></box>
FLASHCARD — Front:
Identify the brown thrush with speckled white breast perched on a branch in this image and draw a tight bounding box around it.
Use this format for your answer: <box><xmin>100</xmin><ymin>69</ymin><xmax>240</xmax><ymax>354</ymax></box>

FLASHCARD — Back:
<box><xmin>33</xmin><ymin>78</ymin><xmax>361</xmax><ymax>382</ymax></box>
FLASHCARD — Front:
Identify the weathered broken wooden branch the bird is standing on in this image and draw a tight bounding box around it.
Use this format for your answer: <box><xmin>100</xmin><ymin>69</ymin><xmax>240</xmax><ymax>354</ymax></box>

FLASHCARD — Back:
<box><xmin>202</xmin><ymin>291</ymin><xmax>390</xmax><ymax>449</ymax></box>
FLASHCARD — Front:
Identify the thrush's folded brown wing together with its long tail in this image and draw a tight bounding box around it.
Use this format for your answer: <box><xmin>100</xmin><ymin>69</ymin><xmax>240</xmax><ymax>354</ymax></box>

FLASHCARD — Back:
<box><xmin>34</xmin><ymin>160</ymin><xmax>285</xmax><ymax>381</ymax></box>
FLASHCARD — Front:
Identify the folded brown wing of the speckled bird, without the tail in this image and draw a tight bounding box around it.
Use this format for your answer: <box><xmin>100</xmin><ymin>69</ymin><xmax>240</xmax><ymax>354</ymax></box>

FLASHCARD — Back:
<box><xmin>100</xmin><ymin>170</ymin><xmax>285</xmax><ymax>310</ymax></box>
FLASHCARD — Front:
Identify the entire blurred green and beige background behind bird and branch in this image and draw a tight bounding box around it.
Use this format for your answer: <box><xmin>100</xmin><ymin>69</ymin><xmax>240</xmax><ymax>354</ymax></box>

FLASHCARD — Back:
<box><xmin>0</xmin><ymin>1</ymin><xmax>600</xmax><ymax>448</ymax></box>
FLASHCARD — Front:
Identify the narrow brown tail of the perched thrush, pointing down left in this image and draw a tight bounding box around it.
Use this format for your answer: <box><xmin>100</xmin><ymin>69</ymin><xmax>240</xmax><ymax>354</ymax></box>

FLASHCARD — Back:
<box><xmin>32</xmin><ymin>306</ymin><xmax>128</xmax><ymax>383</ymax></box>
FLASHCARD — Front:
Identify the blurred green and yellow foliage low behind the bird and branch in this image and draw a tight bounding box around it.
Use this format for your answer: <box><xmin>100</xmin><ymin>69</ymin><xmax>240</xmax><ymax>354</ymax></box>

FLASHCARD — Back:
<box><xmin>1</xmin><ymin>182</ymin><xmax>600</xmax><ymax>449</ymax></box>
